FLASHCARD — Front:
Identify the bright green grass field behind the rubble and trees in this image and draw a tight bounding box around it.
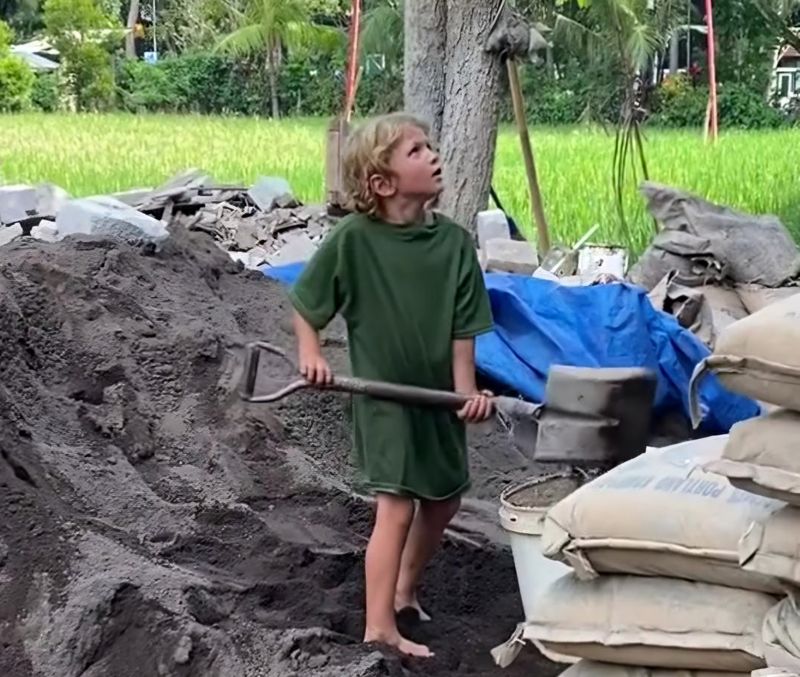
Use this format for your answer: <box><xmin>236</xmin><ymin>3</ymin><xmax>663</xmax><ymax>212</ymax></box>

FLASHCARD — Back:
<box><xmin>0</xmin><ymin>114</ymin><xmax>800</xmax><ymax>254</ymax></box>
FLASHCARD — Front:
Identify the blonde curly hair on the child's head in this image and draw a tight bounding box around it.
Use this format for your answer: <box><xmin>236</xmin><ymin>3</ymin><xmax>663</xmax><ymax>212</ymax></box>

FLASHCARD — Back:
<box><xmin>342</xmin><ymin>112</ymin><xmax>430</xmax><ymax>216</ymax></box>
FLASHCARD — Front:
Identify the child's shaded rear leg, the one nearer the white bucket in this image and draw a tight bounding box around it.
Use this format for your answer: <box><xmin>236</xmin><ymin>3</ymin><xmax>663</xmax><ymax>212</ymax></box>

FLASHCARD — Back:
<box><xmin>394</xmin><ymin>498</ymin><xmax>461</xmax><ymax>621</ymax></box>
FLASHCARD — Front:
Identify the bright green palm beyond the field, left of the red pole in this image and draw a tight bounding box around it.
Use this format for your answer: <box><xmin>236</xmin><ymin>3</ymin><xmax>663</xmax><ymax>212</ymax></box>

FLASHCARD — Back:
<box><xmin>216</xmin><ymin>0</ymin><xmax>344</xmax><ymax>118</ymax></box>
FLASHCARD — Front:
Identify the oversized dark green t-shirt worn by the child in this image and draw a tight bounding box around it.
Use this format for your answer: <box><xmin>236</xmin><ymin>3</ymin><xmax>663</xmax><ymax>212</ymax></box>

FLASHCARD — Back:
<box><xmin>290</xmin><ymin>214</ymin><xmax>492</xmax><ymax>500</ymax></box>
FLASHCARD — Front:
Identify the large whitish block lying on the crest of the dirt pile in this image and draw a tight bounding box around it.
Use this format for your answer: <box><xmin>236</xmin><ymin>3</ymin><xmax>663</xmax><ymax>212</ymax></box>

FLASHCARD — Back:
<box><xmin>56</xmin><ymin>196</ymin><xmax>169</xmax><ymax>243</ymax></box>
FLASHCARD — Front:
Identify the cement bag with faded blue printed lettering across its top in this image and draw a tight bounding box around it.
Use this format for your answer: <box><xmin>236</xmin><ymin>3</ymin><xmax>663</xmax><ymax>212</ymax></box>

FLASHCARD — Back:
<box><xmin>542</xmin><ymin>435</ymin><xmax>785</xmax><ymax>593</ymax></box>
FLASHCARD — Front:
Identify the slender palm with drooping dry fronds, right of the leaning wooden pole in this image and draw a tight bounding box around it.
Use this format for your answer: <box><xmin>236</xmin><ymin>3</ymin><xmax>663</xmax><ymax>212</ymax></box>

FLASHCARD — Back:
<box><xmin>553</xmin><ymin>0</ymin><xmax>687</xmax><ymax>242</ymax></box>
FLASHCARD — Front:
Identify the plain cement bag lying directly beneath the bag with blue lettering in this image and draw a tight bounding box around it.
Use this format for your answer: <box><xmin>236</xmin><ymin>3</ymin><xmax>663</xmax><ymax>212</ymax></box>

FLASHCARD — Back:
<box><xmin>524</xmin><ymin>574</ymin><xmax>777</xmax><ymax>672</ymax></box>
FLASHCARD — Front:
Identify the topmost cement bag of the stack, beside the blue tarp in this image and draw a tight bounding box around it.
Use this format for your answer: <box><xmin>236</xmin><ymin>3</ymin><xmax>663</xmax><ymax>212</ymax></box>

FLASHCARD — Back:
<box><xmin>689</xmin><ymin>294</ymin><xmax>800</xmax><ymax>418</ymax></box>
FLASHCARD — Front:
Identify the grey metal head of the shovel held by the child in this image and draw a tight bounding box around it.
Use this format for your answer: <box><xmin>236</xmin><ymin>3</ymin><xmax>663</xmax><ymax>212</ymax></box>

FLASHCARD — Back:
<box><xmin>533</xmin><ymin>365</ymin><xmax>656</xmax><ymax>467</ymax></box>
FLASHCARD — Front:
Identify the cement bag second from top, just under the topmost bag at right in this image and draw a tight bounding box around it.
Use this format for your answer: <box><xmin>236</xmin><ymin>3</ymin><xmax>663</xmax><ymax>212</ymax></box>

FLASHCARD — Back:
<box><xmin>704</xmin><ymin>409</ymin><xmax>800</xmax><ymax>506</ymax></box>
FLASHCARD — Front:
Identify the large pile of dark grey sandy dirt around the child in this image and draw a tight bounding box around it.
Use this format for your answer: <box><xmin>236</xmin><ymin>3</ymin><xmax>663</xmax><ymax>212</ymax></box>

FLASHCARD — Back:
<box><xmin>0</xmin><ymin>229</ymin><xmax>558</xmax><ymax>677</ymax></box>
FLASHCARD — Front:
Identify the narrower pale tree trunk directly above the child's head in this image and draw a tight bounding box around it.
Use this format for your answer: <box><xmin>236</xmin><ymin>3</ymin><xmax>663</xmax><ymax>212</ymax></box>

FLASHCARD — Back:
<box><xmin>403</xmin><ymin>0</ymin><xmax>447</xmax><ymax>142</ymax></box>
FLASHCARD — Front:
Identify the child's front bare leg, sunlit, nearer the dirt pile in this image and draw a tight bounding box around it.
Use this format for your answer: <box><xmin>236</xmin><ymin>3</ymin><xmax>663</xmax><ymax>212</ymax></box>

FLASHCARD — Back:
<box><xmin>364</xmin><ymin>494</ymin><xmax>432</xmax><ymax>656</ymax></box>
